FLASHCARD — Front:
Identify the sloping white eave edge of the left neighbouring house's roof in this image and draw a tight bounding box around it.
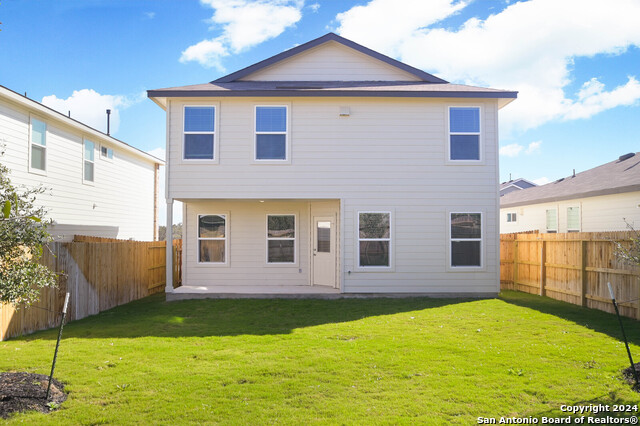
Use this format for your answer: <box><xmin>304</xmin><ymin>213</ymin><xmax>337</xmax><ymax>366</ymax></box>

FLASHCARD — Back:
<box><xmin>0</xmin><ymin>85</ymin><xmax>164</xmax><ymax>165</ymax></box>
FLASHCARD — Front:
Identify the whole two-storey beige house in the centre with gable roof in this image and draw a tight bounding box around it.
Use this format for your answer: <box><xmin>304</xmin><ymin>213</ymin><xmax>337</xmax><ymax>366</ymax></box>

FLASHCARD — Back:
<box><xmin>148</xmin><ymin>34</ymin><xmax>516</xmax><ymax>298</ymax></box>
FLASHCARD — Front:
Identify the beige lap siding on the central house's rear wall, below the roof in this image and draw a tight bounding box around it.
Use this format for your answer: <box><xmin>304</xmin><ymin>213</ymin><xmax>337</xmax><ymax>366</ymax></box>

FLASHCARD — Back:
<box><xmin>168</xmin><ymin>98</ymin><xmax>499</xmax><ymax>293</ymax></box>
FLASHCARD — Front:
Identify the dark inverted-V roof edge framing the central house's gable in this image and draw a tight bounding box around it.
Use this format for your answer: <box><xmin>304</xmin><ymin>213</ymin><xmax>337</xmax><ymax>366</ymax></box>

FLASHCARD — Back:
<box><xmin>211</xmin><ymin>33</ymin><xmax>448</xmax><ymax>83</ymax></box>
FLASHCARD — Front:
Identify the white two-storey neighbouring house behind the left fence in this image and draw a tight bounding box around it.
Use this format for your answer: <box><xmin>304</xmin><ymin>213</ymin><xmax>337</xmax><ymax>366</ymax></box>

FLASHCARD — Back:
<box><xmin>0</xmin><ymin>86</ymin><xmax>164</xmax><ymax>241</ymax></box>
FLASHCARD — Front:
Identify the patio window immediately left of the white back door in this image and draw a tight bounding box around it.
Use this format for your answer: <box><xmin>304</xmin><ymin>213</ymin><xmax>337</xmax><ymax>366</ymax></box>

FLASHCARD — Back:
<box><xmin>267</xmin><ymin>214</ymin><xmax>296</xmax><ymax>263</ymax></box>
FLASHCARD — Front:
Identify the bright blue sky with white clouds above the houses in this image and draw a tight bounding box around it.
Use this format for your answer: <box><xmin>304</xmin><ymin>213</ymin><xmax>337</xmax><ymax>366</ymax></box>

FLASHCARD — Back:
<box><xmin>0</xmin><ymin>0</ymin><xmax>640</xmax><ymax>192</ymax></box>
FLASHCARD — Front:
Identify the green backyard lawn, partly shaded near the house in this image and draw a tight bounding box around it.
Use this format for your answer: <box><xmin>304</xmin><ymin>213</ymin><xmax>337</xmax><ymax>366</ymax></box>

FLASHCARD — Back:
<box><xmin>0</xmin><ymin>292</ymin><xmax>640</xmax><ymax>425</ymax></box>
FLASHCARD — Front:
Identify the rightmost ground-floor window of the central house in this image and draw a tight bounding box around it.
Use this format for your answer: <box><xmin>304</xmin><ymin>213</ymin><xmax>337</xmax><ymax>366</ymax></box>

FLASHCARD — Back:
<box><xmin>450</xmin><ymin>213</ymin><xmax>482</xmax><ymax>267</ymax></box>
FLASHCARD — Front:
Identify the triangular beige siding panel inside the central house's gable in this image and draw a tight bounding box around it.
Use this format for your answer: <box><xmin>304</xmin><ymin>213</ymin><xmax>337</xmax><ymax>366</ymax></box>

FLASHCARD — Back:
<box><xmin>241</xmin><ymin>42</ymin><xmax>419</xmax><ymax>81</ymax></box>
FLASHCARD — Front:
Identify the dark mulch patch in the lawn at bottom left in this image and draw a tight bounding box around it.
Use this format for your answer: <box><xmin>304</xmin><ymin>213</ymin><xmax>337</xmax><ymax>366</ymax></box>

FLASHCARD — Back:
<box><xmin>0</xmin><ymin>373</ymin><xmax>67</xmax><ymax>419</ymax></box>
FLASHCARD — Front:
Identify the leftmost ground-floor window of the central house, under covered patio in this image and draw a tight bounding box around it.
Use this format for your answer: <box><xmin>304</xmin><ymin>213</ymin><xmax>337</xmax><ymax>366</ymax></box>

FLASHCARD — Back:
<box><xmin>198</xmin><ymin>214</ymin><xmax>227</xmax><ymax>263</ymax></box>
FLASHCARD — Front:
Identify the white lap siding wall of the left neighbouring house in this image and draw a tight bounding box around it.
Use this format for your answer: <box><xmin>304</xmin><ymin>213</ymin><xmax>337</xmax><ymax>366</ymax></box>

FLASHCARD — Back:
<box><xmin>0</xmin><ymin>100</ymin><xmax>155</xmax><ymax>240</ymax></box>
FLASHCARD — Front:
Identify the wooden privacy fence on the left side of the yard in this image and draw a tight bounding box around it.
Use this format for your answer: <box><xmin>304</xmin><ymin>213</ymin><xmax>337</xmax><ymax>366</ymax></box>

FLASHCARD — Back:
<box><xmin>0</xmin><ymin>237</ymin><xmax>182</xmax><ymax>341</ymax></box>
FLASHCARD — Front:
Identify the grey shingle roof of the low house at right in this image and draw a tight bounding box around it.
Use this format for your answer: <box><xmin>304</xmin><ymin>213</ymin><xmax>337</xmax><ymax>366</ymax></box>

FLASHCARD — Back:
<box><xmin>500</xmin><ymin>152</ymin><xmax>640</xmax><ymax>208</ymax></box>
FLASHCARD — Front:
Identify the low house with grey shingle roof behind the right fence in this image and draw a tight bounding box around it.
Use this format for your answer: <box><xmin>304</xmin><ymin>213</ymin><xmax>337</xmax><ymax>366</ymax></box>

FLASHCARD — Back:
<box><xmin>500</xmin><ymin>153</ymin><xmax>640</xmax><ymax>233</ymax></box>
